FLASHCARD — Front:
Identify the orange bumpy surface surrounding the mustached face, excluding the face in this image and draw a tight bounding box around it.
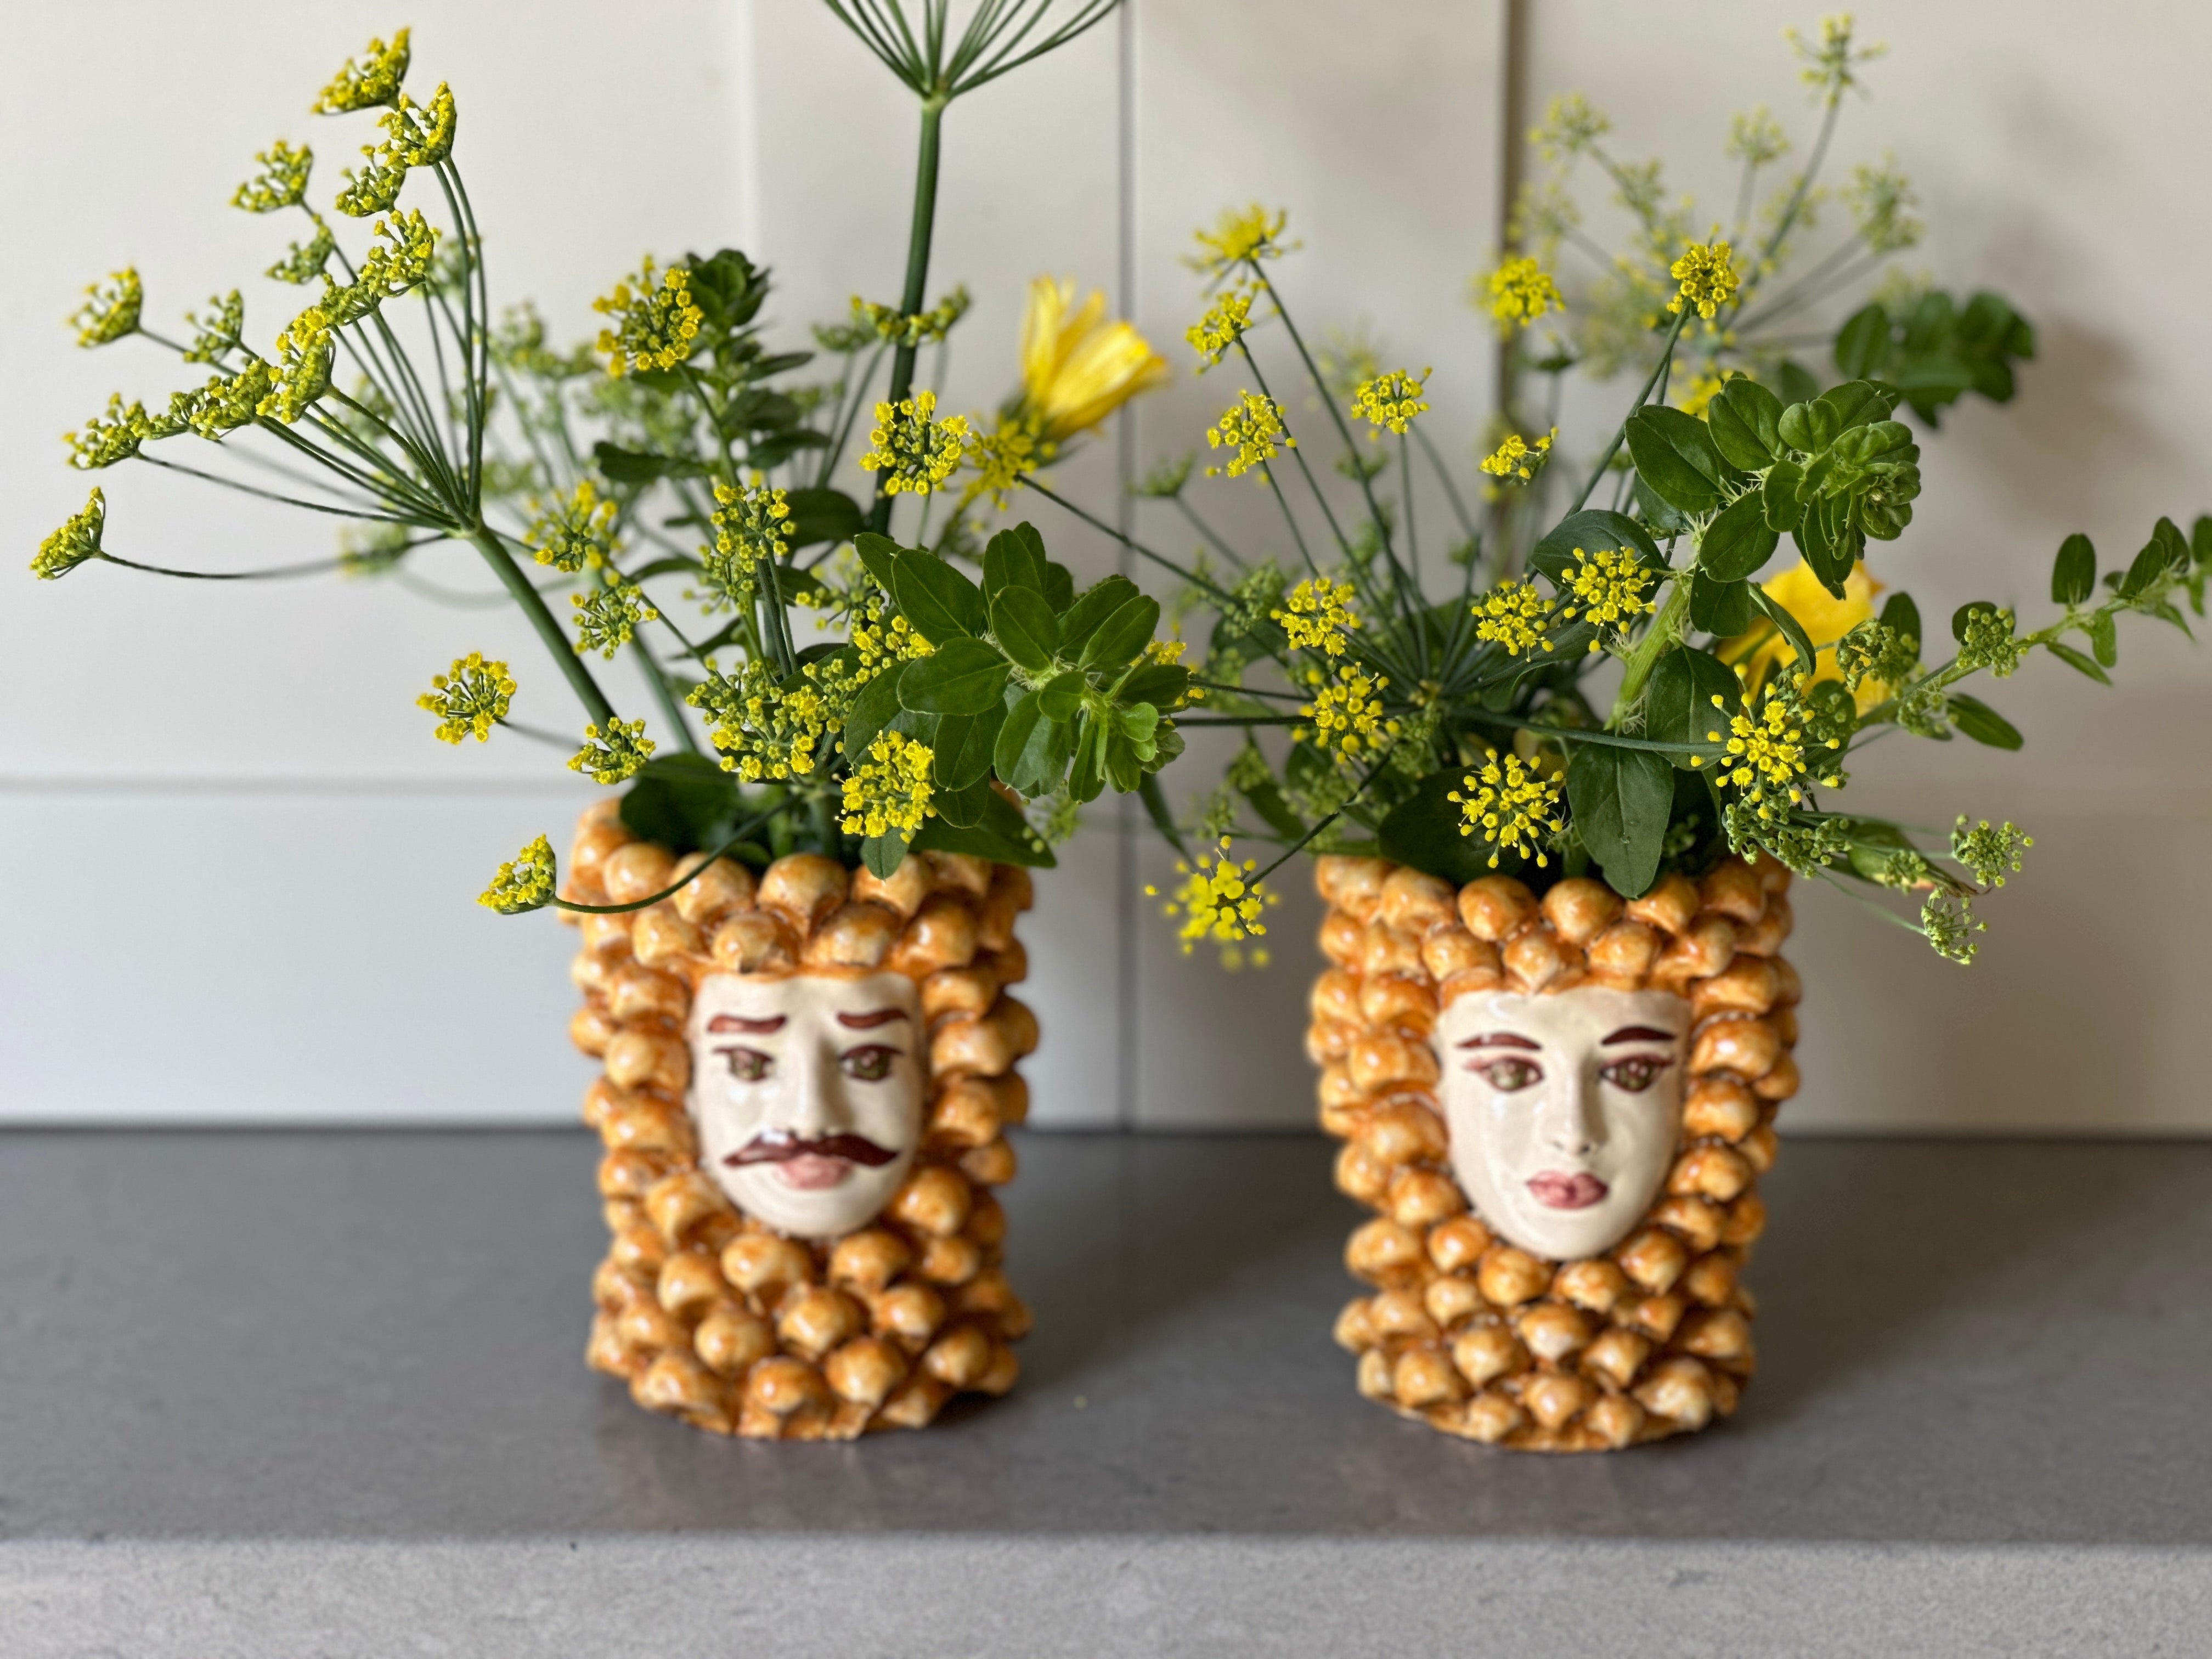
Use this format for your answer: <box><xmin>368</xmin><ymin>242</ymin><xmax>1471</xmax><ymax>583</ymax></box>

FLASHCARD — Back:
<box><xmin>566</xmin><ymin>810</ymin><xmax>1037</xmax><ymax>1440</ymax></box>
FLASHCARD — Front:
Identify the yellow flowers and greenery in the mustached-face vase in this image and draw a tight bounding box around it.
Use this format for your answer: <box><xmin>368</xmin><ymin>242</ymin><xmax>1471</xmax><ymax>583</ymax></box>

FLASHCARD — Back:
<box><xmin>31</xmin><ymin>0</ymin><xmax>1190</xmax><ymax>913</ymax></box>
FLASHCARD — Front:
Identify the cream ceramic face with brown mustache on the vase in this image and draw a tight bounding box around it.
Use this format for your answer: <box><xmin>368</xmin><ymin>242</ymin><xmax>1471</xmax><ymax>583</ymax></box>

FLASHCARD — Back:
<box><xmin>686</xmin><ymin>973</ymin><xmax>924</xmax><ymax>1239</ymax></box>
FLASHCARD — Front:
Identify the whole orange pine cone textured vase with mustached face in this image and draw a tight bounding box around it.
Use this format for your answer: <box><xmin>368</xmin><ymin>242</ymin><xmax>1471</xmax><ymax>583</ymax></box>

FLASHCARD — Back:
<box><xmin>564</xmin><ymin>808</ymin><xmax>1037</xmax><ymax>1440</ymax></box>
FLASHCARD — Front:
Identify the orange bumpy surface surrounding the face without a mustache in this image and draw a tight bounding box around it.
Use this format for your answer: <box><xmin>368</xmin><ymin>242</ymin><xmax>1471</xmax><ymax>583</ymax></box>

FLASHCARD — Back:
<box><xmin>1307</xmin><ymin>858</ymin><xmax>1801</xmax><ymax>1451</ymax></box>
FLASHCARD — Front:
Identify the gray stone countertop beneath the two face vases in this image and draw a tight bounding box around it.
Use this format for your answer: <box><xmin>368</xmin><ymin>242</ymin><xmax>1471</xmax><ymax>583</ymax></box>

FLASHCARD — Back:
<box><xmin>0</xmin><ymin>1132</ymin><xmax>2212</xmax><ymax>1655</ymax></box>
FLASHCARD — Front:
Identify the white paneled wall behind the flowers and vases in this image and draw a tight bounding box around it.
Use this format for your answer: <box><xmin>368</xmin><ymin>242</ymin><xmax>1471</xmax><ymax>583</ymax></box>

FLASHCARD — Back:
<box><xmin>0</xmin><ymin>0</ymin><xmax>2212</xmax><ymax>1130</ymax></box>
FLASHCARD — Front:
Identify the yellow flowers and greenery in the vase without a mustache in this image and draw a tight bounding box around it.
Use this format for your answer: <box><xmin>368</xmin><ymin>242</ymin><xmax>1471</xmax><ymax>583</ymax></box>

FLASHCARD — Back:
<box><xmin>1048</xmin><ymin>18</ymin><xmax>2212</xmax><ymax>967</ymax></box>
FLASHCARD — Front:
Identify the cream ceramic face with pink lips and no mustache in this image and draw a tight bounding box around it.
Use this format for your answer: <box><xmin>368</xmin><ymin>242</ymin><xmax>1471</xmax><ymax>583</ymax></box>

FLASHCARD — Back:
<box><xmin>1431</xmin><ymin>989</ymin><xmax>1690</xmax><ymax>1261</ymax></box>
